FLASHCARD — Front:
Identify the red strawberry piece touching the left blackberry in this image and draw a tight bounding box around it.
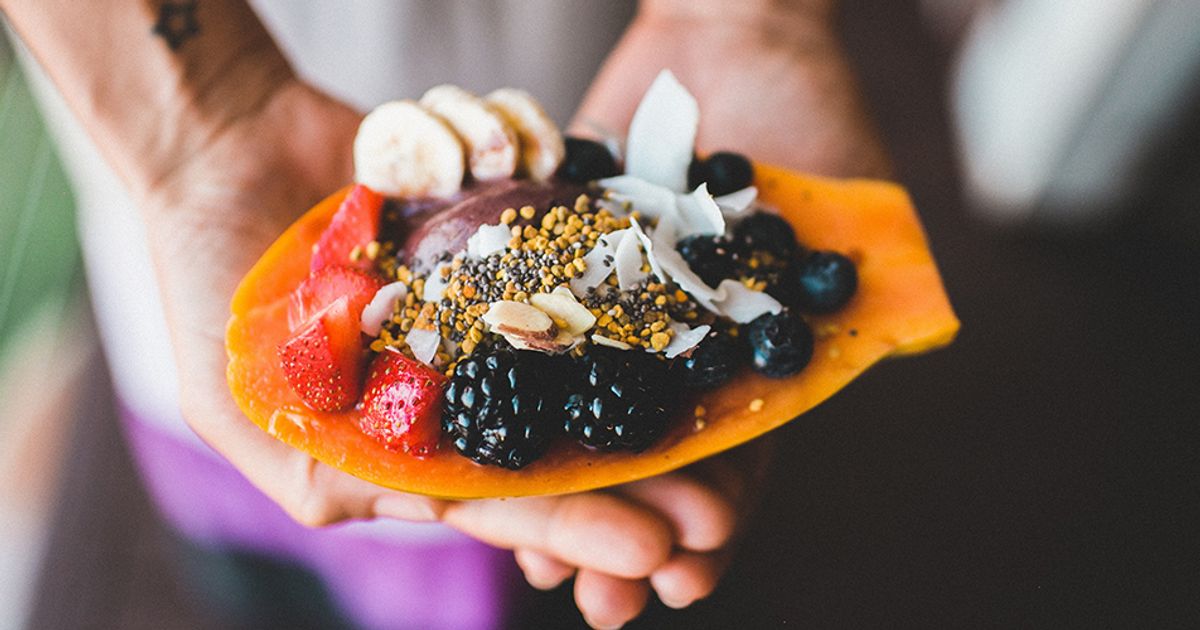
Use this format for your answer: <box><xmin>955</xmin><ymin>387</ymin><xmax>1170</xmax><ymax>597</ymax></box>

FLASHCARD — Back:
<box><xmin>359</xmin><ymin>352</ymin><xmax>446</xmax><ymax>457</ymax></box>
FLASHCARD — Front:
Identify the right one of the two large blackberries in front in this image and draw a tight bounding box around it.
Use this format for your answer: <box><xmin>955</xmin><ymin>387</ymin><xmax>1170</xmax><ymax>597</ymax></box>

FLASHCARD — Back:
<box><xmin>564</xmin><ymin>347</ymin><xmax>672</xmax><ymax>451</ymax></box>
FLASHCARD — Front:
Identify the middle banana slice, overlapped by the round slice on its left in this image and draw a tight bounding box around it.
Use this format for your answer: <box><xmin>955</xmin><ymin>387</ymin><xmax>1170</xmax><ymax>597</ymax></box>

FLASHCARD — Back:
<box><xmin>421</xmin><ymin>85</ymin><xmax>518</xmax><ymax>181</ymax></box>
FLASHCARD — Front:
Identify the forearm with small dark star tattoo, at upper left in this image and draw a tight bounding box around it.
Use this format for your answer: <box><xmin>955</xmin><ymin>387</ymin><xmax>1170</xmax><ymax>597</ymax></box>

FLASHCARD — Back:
<box><xmin>0</xmin><ymin>0</ymin><xmax>293</xmax><ymax>196</ymax></box>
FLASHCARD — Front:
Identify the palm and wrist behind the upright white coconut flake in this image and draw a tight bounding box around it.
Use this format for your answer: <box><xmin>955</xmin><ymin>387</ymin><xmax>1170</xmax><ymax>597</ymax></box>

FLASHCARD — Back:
<box><xmin>571</xmin><ymin>0</ymin><xmax>890</xmax><ymax>176</ymax></box>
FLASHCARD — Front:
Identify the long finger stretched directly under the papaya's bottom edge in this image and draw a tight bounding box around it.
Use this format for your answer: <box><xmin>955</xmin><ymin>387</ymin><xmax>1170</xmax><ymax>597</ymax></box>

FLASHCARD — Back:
<box><xmin>443</xmin><ymin>492</ymin><xmax>673</xmax><ymax>577</ymax></box>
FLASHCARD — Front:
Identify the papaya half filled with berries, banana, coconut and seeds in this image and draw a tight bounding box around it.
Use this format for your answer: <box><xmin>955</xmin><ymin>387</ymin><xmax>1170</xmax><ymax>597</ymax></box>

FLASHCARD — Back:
<box><xmin>227</xmin><ymin>72</ymin><xmax>959</xmax><ymax>498</ymax></box>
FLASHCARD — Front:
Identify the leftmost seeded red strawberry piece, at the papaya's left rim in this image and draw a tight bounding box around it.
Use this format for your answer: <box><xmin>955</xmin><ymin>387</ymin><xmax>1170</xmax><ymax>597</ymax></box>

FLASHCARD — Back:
<box><xmin>277</xmin><ymin>296</ymin><xmax>362</xmax><ymax>412</ymax></box>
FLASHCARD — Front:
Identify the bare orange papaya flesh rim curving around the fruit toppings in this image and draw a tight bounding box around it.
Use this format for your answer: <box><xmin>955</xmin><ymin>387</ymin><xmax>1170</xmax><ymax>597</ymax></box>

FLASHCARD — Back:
<box><xmin>226</xmin><ymin>164</ymin><xmax>959</xmax><ymax>499</ymax></box>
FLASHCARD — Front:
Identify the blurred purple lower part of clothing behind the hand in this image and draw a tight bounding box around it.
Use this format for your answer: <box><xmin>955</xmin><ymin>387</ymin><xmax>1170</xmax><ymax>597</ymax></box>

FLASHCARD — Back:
<box><xmin>115</xmin><ymin>410</ymin><xmax>520</xmax><ymax>630</ymax></box>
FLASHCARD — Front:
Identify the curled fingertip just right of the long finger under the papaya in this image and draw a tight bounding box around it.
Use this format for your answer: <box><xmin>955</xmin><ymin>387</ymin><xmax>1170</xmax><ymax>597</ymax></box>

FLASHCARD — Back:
<box><xmin>616</xmin><ymin>472</ymin><xmax>743</xmax><ymax>551</ymax></box>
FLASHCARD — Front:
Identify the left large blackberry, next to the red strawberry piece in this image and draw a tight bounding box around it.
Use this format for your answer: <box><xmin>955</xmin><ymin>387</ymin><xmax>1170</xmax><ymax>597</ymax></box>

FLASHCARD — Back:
<box><xmin>442</xmin><ymin>348</ymin><xmax>568</xmax><ymax>470</ymax></box>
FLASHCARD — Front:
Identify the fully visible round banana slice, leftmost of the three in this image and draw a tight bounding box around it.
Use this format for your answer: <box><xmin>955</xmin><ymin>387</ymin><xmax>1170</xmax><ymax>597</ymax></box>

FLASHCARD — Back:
<box><xmin>354</xmin><ymin>101</ymin><xmax>466</xmax><ymax>197</ymax></box>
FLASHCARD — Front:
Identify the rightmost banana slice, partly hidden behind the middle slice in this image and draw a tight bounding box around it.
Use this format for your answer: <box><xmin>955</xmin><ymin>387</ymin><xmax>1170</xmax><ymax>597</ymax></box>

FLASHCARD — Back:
<box><xmin>484</xmin><ymin>88</ymin><xmax>566</xmax><ymax>181</ymax></box>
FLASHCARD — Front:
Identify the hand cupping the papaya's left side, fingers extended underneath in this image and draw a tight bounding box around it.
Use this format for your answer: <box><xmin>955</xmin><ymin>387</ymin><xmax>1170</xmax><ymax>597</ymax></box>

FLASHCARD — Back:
<box><xmin>140</xmin><ymin>82</ymin><xmax>766</xmax><ymax>626</ymax></box>
